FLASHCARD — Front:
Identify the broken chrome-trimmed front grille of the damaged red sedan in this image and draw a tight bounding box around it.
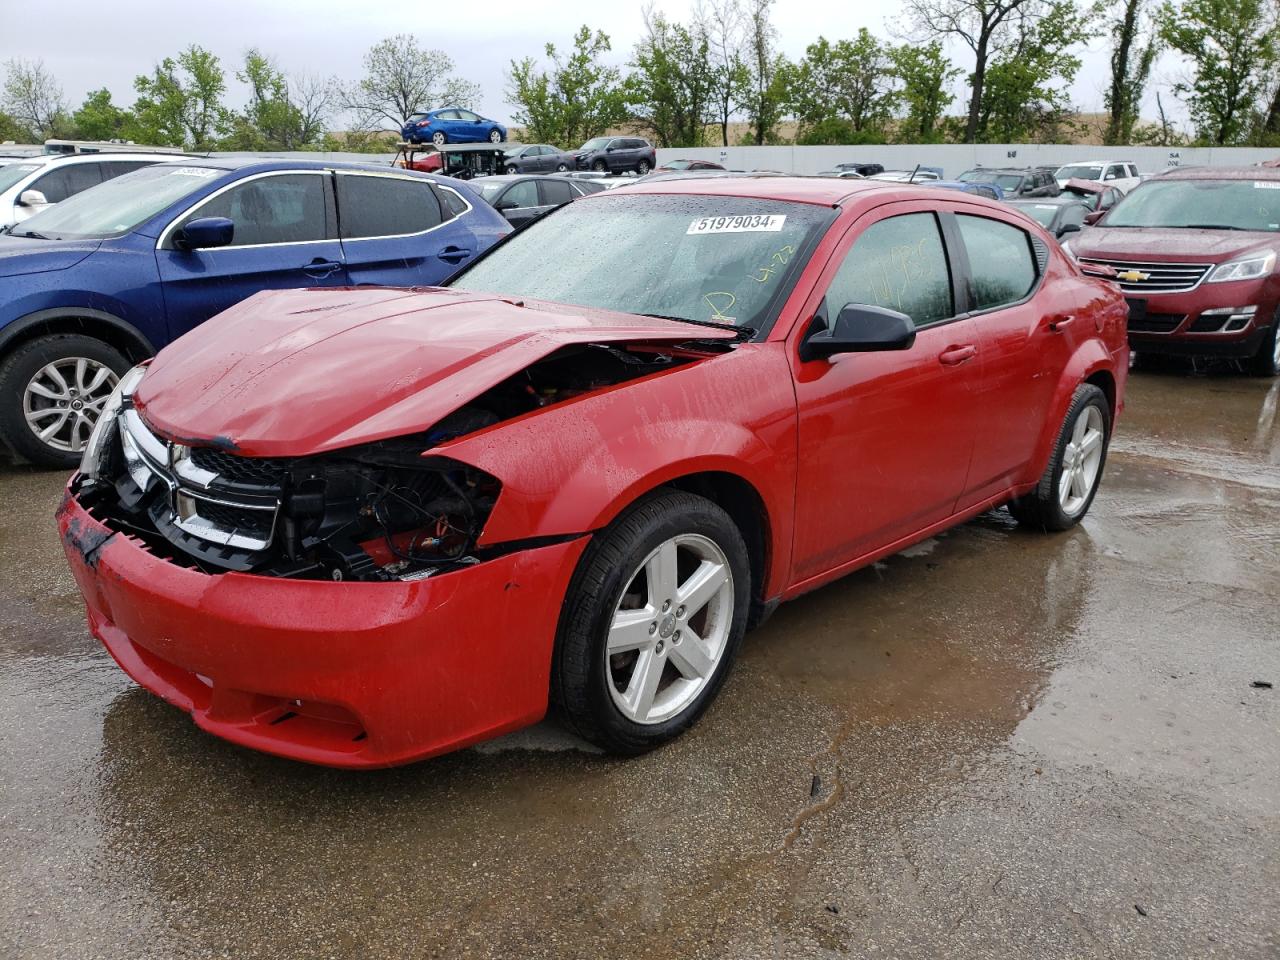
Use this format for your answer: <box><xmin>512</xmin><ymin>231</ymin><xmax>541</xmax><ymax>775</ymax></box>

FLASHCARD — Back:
<box><xmin>120</xmin><ymin>410</ymin><xmax>284</xmax><ymax>550</ymax></box>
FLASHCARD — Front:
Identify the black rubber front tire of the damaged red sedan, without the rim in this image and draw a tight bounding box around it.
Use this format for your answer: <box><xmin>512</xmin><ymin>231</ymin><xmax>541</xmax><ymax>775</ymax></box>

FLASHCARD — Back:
<box><xmin>550</xmin><ymin>490</ymin><xmax>751</xmax><ymax>755</ymax></box>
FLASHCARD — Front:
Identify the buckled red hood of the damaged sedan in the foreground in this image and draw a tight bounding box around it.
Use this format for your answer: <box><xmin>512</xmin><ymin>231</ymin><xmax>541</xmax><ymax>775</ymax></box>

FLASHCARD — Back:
<box><xmin>134</xmin><ymin>288</ymin><xmax>733</xmax><ymax>457</ymax></box>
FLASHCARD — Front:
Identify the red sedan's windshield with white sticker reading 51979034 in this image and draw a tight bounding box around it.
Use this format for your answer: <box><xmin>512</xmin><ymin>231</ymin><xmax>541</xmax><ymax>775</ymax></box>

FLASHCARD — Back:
<box><xmin>449</xmin><ymin>193</ymin><xmax>833</xmax><ymax>330</ymax></box>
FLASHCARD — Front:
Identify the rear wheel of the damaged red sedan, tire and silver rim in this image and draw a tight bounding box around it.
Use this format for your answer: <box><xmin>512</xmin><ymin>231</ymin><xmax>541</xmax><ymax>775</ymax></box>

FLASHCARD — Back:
<box><xmin>1009</xmin><ymin>383</ymin><xmax>1111</xmax><ymax>530</ymax></box>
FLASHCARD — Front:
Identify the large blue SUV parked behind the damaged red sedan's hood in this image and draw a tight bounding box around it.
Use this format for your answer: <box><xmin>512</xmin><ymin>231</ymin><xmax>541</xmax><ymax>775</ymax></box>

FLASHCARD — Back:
<box><xmin>0</xmin><ymin>159</ymin><xmax>511</xmax><ymax>466</ymax></box>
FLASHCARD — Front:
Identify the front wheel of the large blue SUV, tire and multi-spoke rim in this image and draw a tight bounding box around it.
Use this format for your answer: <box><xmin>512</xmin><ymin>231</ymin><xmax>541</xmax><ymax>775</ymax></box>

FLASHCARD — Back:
<box><xmin>0</xmin><ymin>334</ymin><xmax>129</xmax><ymax>468</ymax></box>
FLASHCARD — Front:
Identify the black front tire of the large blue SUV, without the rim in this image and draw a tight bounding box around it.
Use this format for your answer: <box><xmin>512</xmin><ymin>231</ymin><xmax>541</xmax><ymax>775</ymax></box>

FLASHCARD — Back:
<box><xmin>0</xmin><ymin>334</ymin><xmax>131</xmax><ymax>470</ymax></box>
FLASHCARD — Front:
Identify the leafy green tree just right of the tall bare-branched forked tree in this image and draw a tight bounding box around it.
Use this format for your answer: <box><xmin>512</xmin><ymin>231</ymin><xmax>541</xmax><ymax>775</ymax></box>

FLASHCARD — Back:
<box><xmin>978</xmin><ymin>0</ymin><xmax>1089</xmax><ymax>143</ymax></box>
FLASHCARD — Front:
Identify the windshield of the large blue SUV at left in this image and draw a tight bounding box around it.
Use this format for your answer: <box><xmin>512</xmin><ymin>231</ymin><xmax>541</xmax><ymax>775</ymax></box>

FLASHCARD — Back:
<box><xmin>13</xmin><ymin>164</ymin><xmax>227</xmax><ymax>239</ymax></box>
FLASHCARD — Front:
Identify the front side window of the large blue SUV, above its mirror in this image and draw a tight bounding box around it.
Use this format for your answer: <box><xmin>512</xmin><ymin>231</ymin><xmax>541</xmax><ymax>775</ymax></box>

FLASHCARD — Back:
<box><xmin>192</xmin><ymin>174</ymin><xmax>326</xmax><ymax>247</ymax></box>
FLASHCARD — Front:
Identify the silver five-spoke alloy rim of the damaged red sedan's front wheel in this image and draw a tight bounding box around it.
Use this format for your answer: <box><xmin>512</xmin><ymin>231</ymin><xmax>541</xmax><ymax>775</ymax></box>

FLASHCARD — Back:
<box><xmin>604</xmin><ymin>534</ymin><xmax>733</xmax><ymax>724</ymax></box>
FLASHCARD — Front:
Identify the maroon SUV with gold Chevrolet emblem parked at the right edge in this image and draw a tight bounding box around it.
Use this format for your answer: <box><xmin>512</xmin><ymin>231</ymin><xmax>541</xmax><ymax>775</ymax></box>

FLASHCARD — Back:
<box><xmin>1068</xmin><ymin>166</ymin><xmax>1280</xmax><ymax>376</ymax></box>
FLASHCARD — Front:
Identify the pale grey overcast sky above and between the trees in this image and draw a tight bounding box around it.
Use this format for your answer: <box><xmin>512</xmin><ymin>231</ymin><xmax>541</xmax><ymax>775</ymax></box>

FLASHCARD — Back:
<box><xmin>0</xmin><ymin>0</ymin><xmax>1183</xmax><ymax>131</ymax></box>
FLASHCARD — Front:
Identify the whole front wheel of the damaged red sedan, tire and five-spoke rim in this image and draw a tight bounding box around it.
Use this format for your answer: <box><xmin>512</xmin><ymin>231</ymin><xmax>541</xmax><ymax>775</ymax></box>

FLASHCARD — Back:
<box><xmin>552</xmin><ymin>490</ymin><xmax>751</xmax><ymax>754</ymax></box>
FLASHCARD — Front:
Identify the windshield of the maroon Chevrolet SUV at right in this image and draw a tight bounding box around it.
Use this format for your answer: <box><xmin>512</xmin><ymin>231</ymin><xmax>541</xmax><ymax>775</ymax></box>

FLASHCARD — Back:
<box><xmin>1105</xmin><ymin>180</ymin><xmax>1280</xmax><ymax>233</ymax></box>
